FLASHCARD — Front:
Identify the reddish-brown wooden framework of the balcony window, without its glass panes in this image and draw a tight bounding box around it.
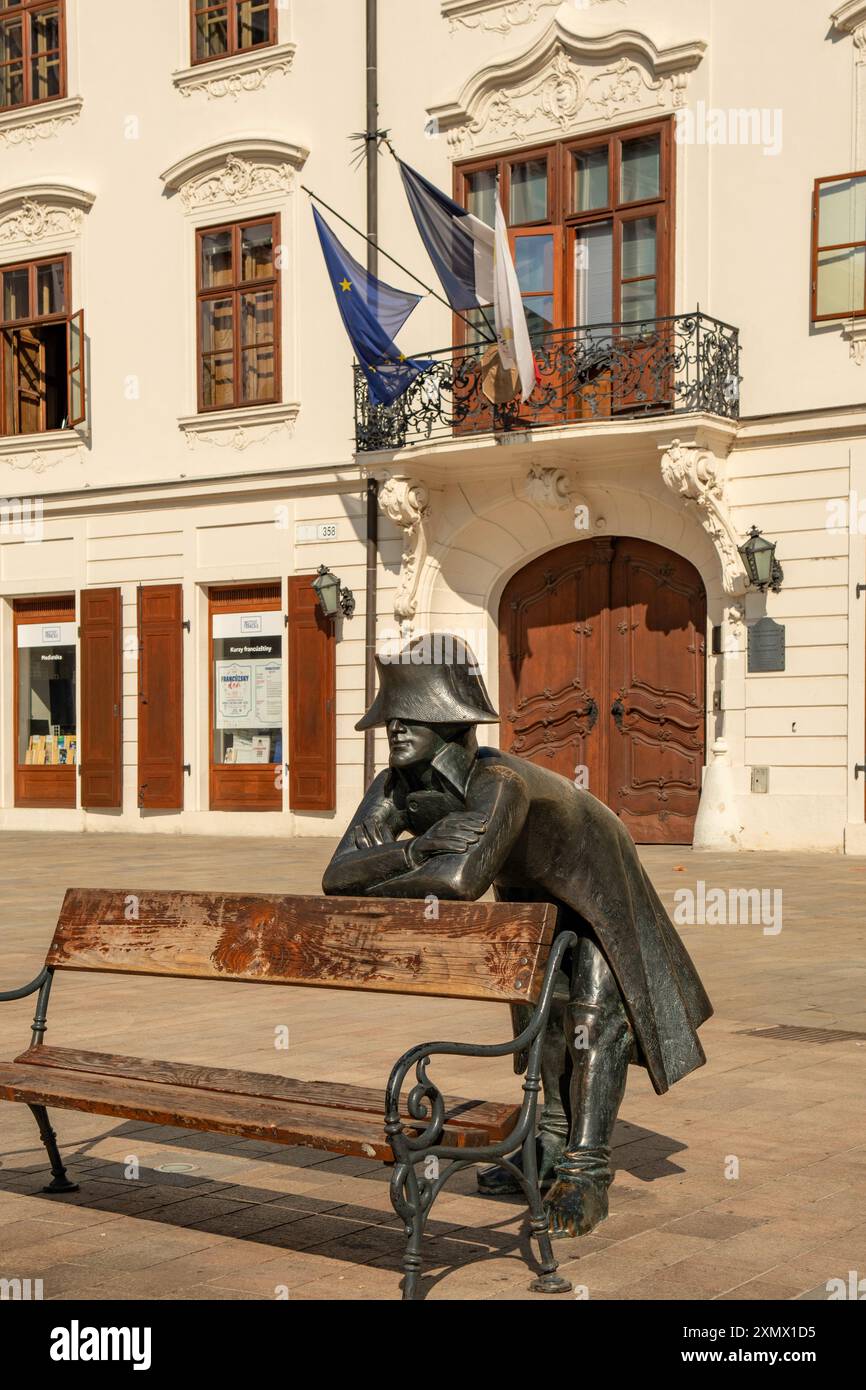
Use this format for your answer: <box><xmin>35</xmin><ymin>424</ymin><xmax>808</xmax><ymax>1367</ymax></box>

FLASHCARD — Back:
<box><xmin>453</xmin><ymin>117</ymin><xmax>678</xmax><ymax>343</ymax></box>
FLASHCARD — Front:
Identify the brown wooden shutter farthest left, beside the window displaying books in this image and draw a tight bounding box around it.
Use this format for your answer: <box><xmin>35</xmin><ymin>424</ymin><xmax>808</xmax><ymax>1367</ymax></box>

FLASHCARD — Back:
<box><xmin>81</xmin><ymin>589</ymin><xmax>124</xmax><ymax>810</ymax></box>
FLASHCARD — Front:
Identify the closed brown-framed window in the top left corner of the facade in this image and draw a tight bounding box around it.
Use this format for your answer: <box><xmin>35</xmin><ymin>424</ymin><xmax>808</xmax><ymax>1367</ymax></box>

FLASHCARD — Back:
<box><xmin>0</xmin><ymin>0</ymin><xmax>67</xmax><ymax>111</ymax></box>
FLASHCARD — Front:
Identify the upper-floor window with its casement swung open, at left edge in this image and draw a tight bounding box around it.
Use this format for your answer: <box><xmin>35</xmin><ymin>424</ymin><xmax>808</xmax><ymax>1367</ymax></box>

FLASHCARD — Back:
<box><xmin>0</xmin><ymin>256</ymin><xmax>86</xmax><ymax>435</ymax></box>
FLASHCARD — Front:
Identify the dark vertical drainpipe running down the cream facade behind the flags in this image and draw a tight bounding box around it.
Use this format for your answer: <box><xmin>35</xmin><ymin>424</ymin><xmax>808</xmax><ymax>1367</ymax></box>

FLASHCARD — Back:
<box><xmin>364</xmin><ymin>0</ymin><xmax>379</xmax><ymax>788</ymax></box>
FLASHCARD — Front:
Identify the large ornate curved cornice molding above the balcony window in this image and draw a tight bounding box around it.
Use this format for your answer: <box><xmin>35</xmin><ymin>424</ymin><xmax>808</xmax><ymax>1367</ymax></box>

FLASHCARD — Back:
<box><xmin>428</xmin><ymin>18</ymin><xmax>706</xmax><ymax>156</ymax></box>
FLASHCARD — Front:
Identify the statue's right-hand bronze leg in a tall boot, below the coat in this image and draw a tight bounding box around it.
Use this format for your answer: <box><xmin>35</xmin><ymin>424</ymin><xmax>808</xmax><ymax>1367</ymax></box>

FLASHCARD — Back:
<box><xmin>548</xmin><ymin>937</ymin><xmax>634</xmax><ymax>1236</ymax></box>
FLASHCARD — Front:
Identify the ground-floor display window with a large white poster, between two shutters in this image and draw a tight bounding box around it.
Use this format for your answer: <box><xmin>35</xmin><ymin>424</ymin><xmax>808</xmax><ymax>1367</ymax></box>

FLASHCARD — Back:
<box><xmin>210</xmin><ymin>584</ymin><xmax>285</xmax><ymax>810</ymax></box>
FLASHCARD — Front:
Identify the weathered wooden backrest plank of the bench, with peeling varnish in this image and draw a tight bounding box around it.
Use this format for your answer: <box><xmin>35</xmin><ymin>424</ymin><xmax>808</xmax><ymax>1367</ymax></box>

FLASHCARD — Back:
<box><xmin>46</xmin><ymin>888</ymin><xmax>556</xmax><ymax>1004</ymax></box>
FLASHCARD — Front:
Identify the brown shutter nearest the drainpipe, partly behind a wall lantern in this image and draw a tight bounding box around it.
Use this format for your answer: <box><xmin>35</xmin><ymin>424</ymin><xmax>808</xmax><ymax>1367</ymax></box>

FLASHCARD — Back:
<box><xmin>289</xmin><ymin>574</ymin><xmax>336</xmax><ymax>810</ymax></box>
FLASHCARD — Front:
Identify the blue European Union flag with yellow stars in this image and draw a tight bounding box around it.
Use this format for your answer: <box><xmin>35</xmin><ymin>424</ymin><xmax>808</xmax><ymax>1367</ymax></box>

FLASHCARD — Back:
<box><xmin>313</xmin><ymin>209</ymin><xmax>431</xmax><ymax>406</ymax></box>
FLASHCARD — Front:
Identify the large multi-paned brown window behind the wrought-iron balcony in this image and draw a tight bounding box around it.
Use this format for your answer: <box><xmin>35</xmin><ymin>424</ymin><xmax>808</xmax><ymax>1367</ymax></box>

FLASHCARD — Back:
<box><xmin>455</xmin><ymin>120</ymin><xmax>674</xmax><ymax>342</ymax></box>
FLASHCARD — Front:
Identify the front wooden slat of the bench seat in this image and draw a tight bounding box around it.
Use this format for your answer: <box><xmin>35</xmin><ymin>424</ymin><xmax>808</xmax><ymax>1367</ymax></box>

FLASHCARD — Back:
<box><xmin>0</xmin><ymin>1062</ymin><xmax>508</xmax><ymax>1162</ymax></box>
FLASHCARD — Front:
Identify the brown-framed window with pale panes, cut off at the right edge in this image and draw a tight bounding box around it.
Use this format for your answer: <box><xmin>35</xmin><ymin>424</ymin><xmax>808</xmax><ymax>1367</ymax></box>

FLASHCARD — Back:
<box><xmin>812</xmin><ymin>172</ymin><xmax>866</xmax><ymax>321</ymax></box>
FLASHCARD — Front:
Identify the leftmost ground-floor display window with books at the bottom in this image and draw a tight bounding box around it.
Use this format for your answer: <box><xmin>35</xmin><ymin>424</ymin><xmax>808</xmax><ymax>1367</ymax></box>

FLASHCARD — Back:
<box><xmin>14</xmin><ymin>595</ymin><xmax>79</xmax><ymax>808</ymax></box>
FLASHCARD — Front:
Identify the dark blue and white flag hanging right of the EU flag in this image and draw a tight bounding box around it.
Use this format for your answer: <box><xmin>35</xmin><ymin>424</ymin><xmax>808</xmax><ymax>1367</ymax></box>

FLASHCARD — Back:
<box><xmin>399</xmin><ymin>160</ymin><xmax>537</xmax><ymax>400</ymax></box>
